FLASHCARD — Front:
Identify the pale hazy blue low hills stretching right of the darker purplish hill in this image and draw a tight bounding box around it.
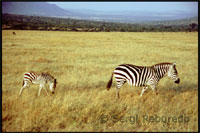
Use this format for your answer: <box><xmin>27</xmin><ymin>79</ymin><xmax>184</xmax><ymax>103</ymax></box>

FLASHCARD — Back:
<box><xmin>66</xmin><ymin>8</ymin><xmax>197</xmax><ymax>23</ymax></box>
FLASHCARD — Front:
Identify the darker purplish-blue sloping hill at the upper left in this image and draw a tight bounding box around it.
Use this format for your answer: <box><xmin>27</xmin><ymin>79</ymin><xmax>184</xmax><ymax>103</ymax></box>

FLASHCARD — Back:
<box><xmin>2</xmin><ymin>2</ymin><xmax>70</xmax><ymax>16</ymax></box>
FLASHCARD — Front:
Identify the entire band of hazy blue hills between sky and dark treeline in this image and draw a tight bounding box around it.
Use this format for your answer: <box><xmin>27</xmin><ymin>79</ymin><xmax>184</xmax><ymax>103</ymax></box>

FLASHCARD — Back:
<box><xmin>2</xmin><ymin>2</ymin><xmax>198</xmax><ymax>23</ymax></box>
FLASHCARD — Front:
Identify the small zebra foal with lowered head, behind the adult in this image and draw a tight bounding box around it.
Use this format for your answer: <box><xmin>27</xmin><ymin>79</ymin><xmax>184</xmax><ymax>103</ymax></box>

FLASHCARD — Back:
<box><xmin>19</xmin><ymin>72</ymin><xmax>57</xmax><ymax>96</ymax></box>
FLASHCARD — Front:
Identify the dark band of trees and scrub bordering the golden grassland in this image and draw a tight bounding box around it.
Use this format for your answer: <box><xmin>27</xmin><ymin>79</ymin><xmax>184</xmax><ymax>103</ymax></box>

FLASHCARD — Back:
<box><xmin>2</xmin><ymin>14</ymin><xmax>198</xmax><ymax>32</ymax></box>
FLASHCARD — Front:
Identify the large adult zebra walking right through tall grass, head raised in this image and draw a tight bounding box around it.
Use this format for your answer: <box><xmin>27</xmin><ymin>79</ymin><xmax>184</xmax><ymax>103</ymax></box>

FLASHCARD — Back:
<box><xmin>107</xmin><ymin>63</ymin><xmax>180</xmax><ymax>98</ymax></box>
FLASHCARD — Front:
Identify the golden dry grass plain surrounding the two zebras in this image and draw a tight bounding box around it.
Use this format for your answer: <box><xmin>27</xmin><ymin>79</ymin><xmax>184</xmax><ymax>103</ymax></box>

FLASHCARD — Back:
<box><xmin>2</xmin><ymin>30</ymin><xmax>198</xmax><ymax>131</ymax></box>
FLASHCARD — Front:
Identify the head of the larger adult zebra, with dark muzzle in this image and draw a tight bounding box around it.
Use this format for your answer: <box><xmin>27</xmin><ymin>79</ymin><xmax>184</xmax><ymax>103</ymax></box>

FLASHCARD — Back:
<box><xmin>168</xmin><ymin>63</ymin><xmax>180</xmax><ymax>84</ymax></box>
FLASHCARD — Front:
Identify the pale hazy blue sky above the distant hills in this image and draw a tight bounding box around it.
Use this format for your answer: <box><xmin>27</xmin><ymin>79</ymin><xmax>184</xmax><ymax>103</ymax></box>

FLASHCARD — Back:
<box><xmin>49</xmin><ymin>2</ymin><xmax>198</xmax><ymax>14</ymax></box>
